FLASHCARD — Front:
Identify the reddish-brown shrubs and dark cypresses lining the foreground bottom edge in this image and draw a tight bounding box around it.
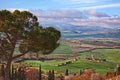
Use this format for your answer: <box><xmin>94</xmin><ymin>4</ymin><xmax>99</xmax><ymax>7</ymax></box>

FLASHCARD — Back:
<box><xmin>0</xmin><ymin>64</ymin><xmax>120</xmax><ymax>80</ymax></box>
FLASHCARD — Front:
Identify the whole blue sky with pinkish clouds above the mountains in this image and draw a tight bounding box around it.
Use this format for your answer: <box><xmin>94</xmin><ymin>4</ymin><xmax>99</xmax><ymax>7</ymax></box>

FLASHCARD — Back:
<box><xmin>0</xmin><ymin>0</ymin><xmax>120</xmax><ymax>28</ymax></box>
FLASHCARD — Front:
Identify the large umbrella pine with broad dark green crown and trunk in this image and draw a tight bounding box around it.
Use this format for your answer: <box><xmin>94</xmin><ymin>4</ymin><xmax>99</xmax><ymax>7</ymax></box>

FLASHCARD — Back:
<box><xmin>0</xmin><ymin>10</ymin><xmax>61</xmax><ymax>80</ymax></box>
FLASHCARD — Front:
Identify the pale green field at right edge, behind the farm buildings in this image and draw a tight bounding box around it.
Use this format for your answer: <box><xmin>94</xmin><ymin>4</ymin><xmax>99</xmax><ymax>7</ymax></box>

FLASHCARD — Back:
<box><xmin>80</xmin><ymin>49</ymin><xmax>120</xmax><ymax>64</ymax></box>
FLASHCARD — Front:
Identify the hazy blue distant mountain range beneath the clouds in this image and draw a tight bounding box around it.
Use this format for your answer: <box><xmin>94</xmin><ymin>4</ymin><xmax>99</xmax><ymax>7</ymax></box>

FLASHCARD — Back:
<box><xmin>42</xmin><ymin>23</ymin><xmax>120</xmax><ymax>38</ymax></box>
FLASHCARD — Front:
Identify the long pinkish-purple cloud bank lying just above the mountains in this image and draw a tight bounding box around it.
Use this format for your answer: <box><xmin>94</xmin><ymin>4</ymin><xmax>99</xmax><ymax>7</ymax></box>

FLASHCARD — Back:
<box><xmin>6</xmin><ymin>9</ymin><xmax>120</xmax><ymax>27</ymax></box>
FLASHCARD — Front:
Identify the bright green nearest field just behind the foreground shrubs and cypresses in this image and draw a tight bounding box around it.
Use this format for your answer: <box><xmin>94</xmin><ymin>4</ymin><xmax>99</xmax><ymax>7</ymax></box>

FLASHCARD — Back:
<box><xmin>23</xmin><ymin>60</ymin><xmax>115</xmax><ymax>73</ymax></box>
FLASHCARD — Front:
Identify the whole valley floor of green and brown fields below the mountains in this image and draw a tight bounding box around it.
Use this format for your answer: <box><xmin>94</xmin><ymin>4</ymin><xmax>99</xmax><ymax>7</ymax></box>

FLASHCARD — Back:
<box><xmin>13</xmin><ymin>39</ymin><xmax>120</xmax><ymax>74</ymax></box>
